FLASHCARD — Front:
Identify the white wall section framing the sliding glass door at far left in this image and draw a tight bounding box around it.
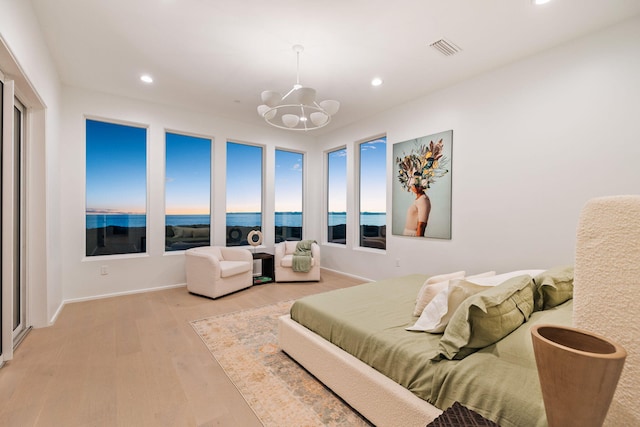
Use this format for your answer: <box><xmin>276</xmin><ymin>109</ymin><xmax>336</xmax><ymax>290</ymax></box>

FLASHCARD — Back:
<box><xmin>0</xmin><ymin>0</ymin><xmax>62</xmax><ymax>327</ymax></box>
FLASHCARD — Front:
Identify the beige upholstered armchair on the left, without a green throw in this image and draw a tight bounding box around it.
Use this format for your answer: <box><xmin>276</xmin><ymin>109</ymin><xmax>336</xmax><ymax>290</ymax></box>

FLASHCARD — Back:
<box><xmin>185</xmin><ymin>246</ymin><xmax>253</xmax><ymax>298</ymax></box>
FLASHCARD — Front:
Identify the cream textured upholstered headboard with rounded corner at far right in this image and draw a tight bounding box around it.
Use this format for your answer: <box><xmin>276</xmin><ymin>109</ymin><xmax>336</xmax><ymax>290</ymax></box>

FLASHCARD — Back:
<box><xmin>573</xmin><ymin>196</ymin><xmax>640</xmax><ymax>426</ymax></box>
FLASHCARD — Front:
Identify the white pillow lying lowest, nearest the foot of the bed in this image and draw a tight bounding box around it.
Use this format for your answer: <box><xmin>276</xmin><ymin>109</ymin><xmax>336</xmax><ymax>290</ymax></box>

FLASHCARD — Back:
<box><xmin>406</xmin><ymin>279</ymin><xmax>487</xmax><ymax>333</ymax></box>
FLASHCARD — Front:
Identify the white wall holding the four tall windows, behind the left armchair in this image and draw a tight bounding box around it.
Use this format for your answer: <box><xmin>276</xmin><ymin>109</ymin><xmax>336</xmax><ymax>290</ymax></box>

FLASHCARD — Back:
<box><xmin>60</xmin><ymin>87</ymin><xmax>318</xmax><ymax>301</ymax></box>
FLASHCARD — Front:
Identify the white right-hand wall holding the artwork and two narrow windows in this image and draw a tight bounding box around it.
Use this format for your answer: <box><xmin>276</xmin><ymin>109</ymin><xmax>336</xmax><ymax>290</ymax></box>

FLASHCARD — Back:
<box><xmin>319</xmin><ymin>19</ymin><xmax>640</xmax><ymax>279</ymax></box>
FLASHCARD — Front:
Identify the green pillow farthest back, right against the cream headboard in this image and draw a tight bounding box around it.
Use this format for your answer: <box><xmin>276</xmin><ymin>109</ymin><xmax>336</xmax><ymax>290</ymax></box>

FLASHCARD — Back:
<box><xmin>533</xmin><ymin>265</ymin><xmax>573</xmax><ymax>311</ymax></box>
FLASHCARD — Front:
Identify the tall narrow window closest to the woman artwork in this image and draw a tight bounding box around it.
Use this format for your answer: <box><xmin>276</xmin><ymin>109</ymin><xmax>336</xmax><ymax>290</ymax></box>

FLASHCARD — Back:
<box><xmin>359</xmin><ymin>137</ymin><xmax>387</xmax><ymax>249</ymax></box>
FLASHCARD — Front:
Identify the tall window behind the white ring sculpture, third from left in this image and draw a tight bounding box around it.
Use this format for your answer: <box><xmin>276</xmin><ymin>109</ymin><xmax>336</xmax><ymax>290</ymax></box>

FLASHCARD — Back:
<box><xmin>227</xmin><ymin>141</ymin><xmax>262</xmax><ymax>246</ymax></box>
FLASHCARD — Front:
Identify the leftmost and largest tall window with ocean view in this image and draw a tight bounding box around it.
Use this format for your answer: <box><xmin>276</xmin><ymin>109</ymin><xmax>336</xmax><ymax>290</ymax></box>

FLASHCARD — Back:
<box><xmin>86</xmin><ymin>120</ymin><xmax>147</xmax><ymax>256</ymax></box>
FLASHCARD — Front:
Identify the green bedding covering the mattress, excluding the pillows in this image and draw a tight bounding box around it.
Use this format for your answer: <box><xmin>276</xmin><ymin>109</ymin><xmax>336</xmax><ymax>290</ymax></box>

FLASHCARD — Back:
<box><xmin>291</xmin><ymin>274</ymin><xmax>572</xmax><ymax>427</ymax></box>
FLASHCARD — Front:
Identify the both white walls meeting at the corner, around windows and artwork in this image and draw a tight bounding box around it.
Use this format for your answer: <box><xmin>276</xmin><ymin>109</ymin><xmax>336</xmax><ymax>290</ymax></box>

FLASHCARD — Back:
<box><xmin>28</xmin><ymin>11</ymin><xmax>640</xmax><ymax>314</ymax></box>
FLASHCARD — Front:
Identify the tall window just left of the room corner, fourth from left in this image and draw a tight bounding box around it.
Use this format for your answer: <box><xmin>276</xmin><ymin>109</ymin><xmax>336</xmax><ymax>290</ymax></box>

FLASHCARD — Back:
<box><xmin>274</xmin><ymin>150</ymin><xmax>304</xmax><ymax>243</ymax></box>
